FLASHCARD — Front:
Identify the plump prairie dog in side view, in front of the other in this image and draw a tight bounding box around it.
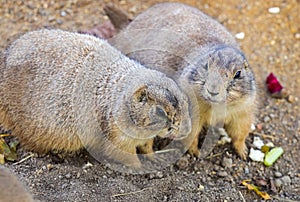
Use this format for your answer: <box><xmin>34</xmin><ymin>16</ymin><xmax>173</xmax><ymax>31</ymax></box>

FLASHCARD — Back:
<box><xmin>0</xmin><ymin>29</ymin><xmax>191</xmax><ymax>168</ymax></box>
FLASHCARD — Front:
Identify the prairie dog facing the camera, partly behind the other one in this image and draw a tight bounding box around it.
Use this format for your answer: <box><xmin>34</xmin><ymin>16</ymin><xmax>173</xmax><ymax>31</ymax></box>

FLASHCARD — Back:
<box><xmin>109</xmin><ymin>3</ymin><xmax>256</xmax><ymax>159</ymax></box>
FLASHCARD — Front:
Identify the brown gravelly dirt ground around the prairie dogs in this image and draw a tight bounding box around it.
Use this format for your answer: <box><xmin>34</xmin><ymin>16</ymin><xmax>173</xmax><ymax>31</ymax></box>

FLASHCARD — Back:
<box><xmin>0</xmin><ymin>0</ymin><xmax>300</xmax><ymax>202</ymax></box>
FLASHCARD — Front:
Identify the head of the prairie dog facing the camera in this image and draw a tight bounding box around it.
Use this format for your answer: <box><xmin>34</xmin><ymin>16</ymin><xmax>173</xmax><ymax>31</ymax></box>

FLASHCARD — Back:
<box><xmin>187</xmin><ymin>46</ymin><xmax>256</xmax><ymax>104</ymax></box>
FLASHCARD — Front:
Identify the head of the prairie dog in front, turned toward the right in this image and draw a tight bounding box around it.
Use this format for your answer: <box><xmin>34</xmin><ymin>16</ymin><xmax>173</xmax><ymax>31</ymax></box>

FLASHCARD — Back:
<box><xmin>113</xmin><ymin>71</ymin><xmax>191</xmax><ymax>139</ymax></box>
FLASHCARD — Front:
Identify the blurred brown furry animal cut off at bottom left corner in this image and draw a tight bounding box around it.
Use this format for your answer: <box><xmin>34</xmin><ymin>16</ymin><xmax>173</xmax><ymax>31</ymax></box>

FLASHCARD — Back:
<box><xmin>0</xmin><ymin>166</ymin><xmax>33</xmax><ymax>202</ymax></box>
